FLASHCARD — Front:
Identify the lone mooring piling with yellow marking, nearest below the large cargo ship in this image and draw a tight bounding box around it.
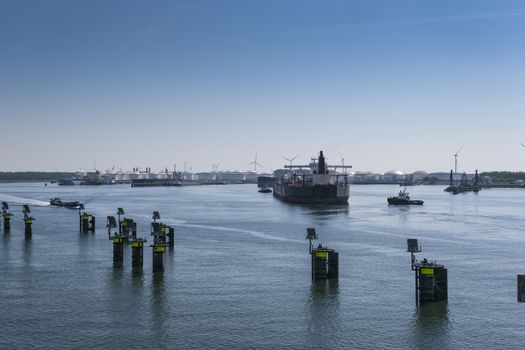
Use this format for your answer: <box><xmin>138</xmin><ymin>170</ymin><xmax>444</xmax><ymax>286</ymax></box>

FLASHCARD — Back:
<box><xmin>306</xmin><ymin>228</ymin><xmax>339</xmax><ymax>281</ymax></box>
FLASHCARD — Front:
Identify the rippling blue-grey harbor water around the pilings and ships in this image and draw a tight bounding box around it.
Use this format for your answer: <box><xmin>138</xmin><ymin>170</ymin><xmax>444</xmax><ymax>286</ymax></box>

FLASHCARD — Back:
<box><xmin>0</xmin><ymin>183</ymin><xmax>525</xmax><ymax>349</ymax></box>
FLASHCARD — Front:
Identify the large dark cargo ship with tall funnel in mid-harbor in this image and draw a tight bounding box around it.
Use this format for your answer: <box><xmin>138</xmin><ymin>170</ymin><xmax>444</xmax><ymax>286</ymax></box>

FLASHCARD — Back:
<box><xmin>273</xmin><ymin>151</ymin><xmax>352</xmax><ymax>204</ymax></box>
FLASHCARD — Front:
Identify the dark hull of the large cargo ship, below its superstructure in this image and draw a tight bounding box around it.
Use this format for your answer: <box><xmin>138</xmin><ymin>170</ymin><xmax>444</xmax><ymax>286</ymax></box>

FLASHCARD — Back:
<box><xmin>273</xmin><ymin>183</ymin><xmax>349</xmax><ymax>204</ymax></box>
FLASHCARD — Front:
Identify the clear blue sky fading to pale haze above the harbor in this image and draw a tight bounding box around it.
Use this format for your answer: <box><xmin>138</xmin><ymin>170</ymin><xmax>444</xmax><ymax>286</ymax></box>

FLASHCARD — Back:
<box><xmin>0</xmin><ymin>0</ymin><xmax>525</xmax><ymax>172</ymax></box>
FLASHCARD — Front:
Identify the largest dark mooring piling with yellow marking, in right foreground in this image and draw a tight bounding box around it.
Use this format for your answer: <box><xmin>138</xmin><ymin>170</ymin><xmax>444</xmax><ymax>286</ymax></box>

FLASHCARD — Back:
<box><xmin>407</xmin><ymin>239</ymin><xmax>448</xmax><ymax>305</ymax></box>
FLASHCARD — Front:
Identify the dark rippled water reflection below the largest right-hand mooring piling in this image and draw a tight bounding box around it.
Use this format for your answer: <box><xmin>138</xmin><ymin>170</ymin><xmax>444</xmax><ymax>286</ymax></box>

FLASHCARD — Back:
<box><xmin>409</xmin><ymin>301</ymin><xmax>449</xmax><ymax>349</ymax></box>
